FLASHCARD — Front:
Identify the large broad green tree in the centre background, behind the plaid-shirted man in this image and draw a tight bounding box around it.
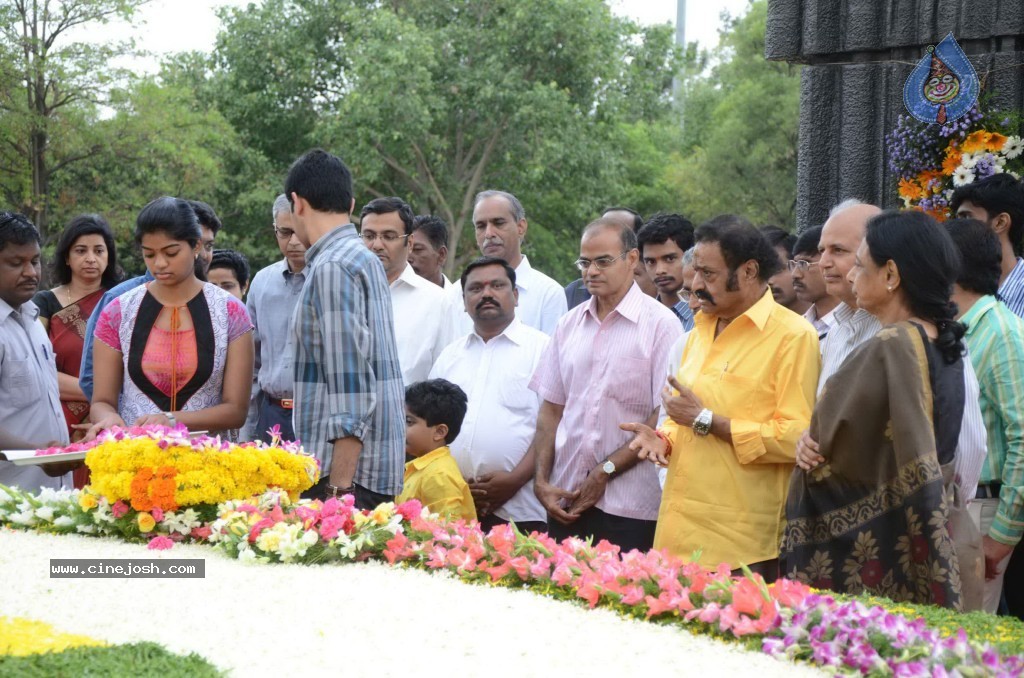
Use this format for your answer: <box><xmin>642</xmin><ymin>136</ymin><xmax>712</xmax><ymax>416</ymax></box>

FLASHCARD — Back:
<box><xmin>208</xmin><ymin>0</ymin><xmax>679</xmax><ymax>279</ymax></box>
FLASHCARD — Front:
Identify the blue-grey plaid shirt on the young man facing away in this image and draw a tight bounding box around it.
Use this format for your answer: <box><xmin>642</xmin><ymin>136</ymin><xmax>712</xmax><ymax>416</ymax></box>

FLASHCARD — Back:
<box><xmin>293</xmin><ymin>223</ymin><xmax>406</xmax><ymax>495</ymax></box>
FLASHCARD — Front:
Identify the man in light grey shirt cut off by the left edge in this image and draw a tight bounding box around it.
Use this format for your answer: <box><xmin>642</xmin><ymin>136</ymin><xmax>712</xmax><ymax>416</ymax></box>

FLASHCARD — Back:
<box><xmin>0</xmin><ymin>212</ymin><xmax>70</xmax><ymax>492</ymax></box>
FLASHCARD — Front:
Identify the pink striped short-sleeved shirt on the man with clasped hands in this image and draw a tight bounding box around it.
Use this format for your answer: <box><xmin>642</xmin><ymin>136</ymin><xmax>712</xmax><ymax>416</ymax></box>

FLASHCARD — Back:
<box><xmin>529</xmin><ymin>283</ymin><xmax>683</xmax><ymax>520</ymax></box>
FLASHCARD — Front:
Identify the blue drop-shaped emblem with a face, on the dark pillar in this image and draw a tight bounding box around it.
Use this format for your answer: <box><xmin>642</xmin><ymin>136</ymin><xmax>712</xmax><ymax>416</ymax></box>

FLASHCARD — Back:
<box><xmin>903</xmin><ymin>33</ymin><xmax>981</xmax><ymax>125</ymax></box>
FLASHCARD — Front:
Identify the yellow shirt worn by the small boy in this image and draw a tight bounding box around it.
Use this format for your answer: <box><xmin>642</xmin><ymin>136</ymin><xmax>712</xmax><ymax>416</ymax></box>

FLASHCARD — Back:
<box><xmin>395</xmin><ymin>446</ymin><xmax>476</xmax><ymax>520</ymax></box>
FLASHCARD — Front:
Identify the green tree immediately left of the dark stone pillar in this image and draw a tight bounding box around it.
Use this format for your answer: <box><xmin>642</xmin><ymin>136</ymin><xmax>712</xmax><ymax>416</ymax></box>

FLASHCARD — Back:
<box><xmin>665</xmin><ymin>0</ymin><xmax>800</xmax><ymax>229</ymax></box>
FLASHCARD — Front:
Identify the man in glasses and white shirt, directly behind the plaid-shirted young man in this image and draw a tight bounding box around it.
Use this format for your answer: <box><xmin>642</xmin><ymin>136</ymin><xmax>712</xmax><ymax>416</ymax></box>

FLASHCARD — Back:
<box><xmin>359</xmin><ymin>198</ymin><xmax>452</xmax><ymax>386</ymax></box>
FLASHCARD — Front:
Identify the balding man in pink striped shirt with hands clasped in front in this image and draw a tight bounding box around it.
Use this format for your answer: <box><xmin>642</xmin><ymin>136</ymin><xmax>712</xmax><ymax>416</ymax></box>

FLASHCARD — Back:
<box><xmin>529</xmin><ymin>219</ymin><xmax>682</xmax><ymax>551</ymax></box>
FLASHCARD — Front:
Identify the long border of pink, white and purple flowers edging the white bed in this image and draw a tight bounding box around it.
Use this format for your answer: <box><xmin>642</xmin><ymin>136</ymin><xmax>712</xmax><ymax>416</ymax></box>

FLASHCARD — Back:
<box><xmin>0</xmin><ymin>485</ymin><xmax>1024</xmax><ymax>676</ymax></box>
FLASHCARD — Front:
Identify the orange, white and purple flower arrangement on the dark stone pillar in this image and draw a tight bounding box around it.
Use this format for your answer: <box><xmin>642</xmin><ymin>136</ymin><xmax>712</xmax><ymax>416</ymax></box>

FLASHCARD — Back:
<box><xmin>886</xmin><ymin>104</ymin><xmax>1024</xmax><ymax>221</ymax></box>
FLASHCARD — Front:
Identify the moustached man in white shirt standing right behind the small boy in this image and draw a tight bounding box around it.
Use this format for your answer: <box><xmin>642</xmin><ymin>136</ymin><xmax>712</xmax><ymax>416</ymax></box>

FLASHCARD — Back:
<box><xmin>430</xmin><ymin>257</ymin><xmax>549</xmax><ymax>534</ymax></box>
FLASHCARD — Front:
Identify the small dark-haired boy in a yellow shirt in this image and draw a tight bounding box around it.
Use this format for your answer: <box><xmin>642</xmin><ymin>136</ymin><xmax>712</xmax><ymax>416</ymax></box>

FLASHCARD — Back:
<box><xmin>395</xmin><ymin>379</ymin><xmax>476</xmax><ymax>520</ymax></box>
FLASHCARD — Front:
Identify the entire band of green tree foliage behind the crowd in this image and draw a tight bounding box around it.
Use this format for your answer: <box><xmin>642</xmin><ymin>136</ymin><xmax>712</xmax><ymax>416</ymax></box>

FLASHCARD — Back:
<box><xmin>0</xmin><ymin>0</ymin><xmax>799</xmax><ymax>281</ymax></box>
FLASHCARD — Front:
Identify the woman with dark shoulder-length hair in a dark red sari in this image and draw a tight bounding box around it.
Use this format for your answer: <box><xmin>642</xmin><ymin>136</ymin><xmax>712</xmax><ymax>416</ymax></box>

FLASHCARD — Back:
<box><xmin>33</xmin><ymin>214</ymin><xmax>121</xmax><ymax>467</ymax></box>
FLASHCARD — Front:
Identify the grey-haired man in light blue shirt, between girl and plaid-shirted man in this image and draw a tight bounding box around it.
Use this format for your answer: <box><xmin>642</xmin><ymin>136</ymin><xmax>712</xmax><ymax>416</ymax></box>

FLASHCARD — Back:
<box><xmin>242</xmin><ymin>194</ymin><xmax>306</xmax><ymax>442</ymax></box>
